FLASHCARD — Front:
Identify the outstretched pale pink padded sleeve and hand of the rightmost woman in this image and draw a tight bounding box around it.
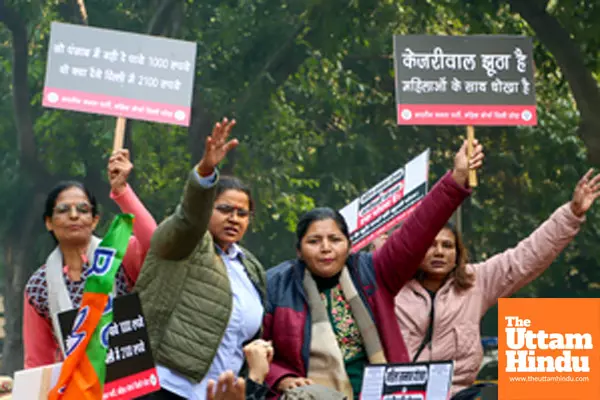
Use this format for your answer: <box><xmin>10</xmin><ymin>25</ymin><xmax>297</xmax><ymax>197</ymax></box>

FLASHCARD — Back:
<box><xmin>473</xmin><ymin>170</ymin><xmax>600</xmax><ymax>315</ymax></box>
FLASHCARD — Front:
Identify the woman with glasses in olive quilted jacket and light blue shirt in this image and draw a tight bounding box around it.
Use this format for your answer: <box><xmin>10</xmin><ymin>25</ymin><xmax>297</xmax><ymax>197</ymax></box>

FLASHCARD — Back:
<box><xmin>136</xmin><ymin>119</ymin><xmax>272</xmax><ymax>400</ymax></box>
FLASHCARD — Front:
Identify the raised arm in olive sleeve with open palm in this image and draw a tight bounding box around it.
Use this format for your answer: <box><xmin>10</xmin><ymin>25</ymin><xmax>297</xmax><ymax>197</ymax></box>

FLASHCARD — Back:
<box><xmin>151</xmin><ymin>118</ymin><xmax>238</xmax><ymax>260</ymax></box>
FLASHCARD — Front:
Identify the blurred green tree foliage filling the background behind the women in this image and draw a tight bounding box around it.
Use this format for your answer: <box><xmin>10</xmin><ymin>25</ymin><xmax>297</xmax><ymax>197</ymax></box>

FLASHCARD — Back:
<box><xmin>0</xmin><ymin>0</ymin><xmax>600</xmax><ymax>376</ymax></box>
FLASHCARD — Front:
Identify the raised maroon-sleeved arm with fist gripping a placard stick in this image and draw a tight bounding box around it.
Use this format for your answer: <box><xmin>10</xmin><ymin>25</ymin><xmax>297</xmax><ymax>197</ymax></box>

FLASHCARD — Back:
<box><xmin>373</xmin><ymin>141</ymin><xmax>484</xmax><ymax>296</ymax></box>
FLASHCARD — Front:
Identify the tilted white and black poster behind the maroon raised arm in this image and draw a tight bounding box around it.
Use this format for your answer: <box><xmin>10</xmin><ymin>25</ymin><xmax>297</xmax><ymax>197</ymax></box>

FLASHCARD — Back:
<box><xmin>340</xmin><ymin>149</ymin><xmax>429</xmax><ymax>252</ymax></box>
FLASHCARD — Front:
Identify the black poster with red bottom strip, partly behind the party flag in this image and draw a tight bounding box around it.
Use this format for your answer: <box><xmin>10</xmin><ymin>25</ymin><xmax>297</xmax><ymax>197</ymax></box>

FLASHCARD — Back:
<box><xmin>58</xmin><ymin>293</ymin><xmax>160</xmax><ymax>400</ymax></box>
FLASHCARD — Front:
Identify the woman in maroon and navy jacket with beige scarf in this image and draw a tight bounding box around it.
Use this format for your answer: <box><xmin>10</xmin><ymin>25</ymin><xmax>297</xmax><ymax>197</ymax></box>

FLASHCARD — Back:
<box><xmin>264</xmin><ymin>143</ymin><xmax>483</xmax><ymax>399</ymax></box>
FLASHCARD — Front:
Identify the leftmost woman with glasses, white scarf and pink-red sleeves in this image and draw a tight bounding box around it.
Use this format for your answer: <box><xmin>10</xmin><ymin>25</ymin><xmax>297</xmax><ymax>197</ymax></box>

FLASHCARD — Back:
<box><xmin>23</xmin><ymin>150</ymin><xmax>156</xmax><ymax>368</ymax></box>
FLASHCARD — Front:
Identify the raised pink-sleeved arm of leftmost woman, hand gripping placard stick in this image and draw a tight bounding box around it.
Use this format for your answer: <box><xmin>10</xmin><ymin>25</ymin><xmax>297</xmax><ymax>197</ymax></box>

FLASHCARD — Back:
<box><xmin>108</xmin><ymin>149</ymin><xmax>156</xmax><ymax>285</ymax></box>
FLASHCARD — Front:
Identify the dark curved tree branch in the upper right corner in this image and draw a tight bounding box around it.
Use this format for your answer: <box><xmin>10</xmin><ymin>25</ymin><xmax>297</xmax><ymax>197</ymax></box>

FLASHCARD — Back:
<box><xmin>508</xmin><ymin>0</ymin><xmax>600</xmax><ymax>164</ymax></box>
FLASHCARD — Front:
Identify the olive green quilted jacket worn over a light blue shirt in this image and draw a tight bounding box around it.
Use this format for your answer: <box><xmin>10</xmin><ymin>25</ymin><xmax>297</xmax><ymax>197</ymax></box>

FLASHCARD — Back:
<box><xmin>135</xmin><ymin>171</ymin><xmax>266</xmax><ymax>382</ymax></box>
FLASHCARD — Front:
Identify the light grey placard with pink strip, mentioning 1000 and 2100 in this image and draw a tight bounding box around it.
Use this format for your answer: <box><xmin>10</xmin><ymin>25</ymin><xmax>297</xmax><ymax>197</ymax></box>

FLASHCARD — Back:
<box><xmin>42</xmin><ymin>22</ymin><xmax>196</xmax><ymax>126</ymax></box>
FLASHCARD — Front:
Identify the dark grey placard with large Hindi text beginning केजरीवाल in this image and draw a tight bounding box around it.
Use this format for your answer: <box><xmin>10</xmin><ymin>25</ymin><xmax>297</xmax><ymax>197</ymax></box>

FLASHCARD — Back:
<box><xmin>394</xmin><ymin>35</ymin><xmax>537</xmax><ymax>126</ymax></box>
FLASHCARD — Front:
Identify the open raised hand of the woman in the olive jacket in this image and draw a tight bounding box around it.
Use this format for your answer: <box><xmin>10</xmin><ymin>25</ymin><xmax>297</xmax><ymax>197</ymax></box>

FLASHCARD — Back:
<box><xmin>198</xmin><ymin>118</ymin><xmax>239</xmax><ymax>176</ymax></box>
